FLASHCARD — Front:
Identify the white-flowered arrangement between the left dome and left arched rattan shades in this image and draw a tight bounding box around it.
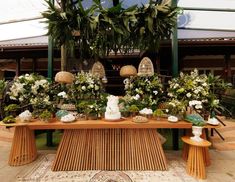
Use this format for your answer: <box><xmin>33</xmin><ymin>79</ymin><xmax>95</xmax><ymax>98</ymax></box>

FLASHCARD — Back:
<box><xmin>72</xmin><ymin>72</ymin><xmax>104</xmax><ymax>100</ymax></box>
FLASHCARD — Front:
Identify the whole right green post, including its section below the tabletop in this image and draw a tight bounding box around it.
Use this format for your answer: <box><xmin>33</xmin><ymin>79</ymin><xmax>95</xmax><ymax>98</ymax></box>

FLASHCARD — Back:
<box><xmin>171</xmin><ymin>0</ymin><xmax>179</xmax><ymax>150</ymax></box>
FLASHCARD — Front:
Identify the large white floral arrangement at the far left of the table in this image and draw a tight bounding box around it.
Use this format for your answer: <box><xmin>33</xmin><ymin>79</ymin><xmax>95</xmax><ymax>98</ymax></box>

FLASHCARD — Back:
<box><xmin>7</xmin><ymin>73</ymin><xmax>53</xmax><ymax>117</ymax></box>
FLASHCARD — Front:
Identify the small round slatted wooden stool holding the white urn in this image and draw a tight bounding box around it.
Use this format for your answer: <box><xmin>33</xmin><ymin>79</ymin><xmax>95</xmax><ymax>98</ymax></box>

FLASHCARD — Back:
<box><xmin>182</xmin><ymin>136</ymin><xmax>211</xmax><ymax>179</ymax></box>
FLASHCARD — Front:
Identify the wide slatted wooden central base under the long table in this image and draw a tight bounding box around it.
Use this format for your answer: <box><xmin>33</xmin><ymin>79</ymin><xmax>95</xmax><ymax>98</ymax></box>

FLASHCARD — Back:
<box><xmin>52</xmin><ymin>129</ymin><xmax>167</xmax><ymax>171</ymax></box>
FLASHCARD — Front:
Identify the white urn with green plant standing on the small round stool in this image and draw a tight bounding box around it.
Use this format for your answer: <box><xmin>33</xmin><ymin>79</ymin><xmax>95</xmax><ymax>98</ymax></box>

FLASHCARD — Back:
<box><xmin>185</xmin><ymin>114</ymin><xmax>206</xmax><ymax>142</ymax></box>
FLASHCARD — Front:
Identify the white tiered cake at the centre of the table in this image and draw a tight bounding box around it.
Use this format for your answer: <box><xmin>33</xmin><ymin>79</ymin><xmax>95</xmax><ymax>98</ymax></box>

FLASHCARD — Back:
<box><xmin>105</xmin><ymin>95</ymin><xmax>121</xmax><ymax>120</ymax></box>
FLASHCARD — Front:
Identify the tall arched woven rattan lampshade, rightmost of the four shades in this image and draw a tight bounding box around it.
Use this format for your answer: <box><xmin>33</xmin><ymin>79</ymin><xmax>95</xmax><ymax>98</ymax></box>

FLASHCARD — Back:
<box><xmin>138</xmin><ymin>57</ymin><xmax>154</xmax><ymax>76</ymax></box>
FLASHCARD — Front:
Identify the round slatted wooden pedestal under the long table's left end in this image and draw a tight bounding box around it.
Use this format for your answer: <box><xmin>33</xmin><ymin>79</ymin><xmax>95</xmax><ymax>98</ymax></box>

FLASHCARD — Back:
<box><xmin>8</xmin><ymin>126</ymin><xmax>37</xmax><ymax>166</ymax></box>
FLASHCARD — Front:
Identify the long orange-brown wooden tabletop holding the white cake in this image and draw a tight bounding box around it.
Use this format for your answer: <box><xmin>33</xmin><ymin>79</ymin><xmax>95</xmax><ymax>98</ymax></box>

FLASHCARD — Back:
<box><xmin>0</xmin><ymin>118</ymin><xmax>220</xmax><ymax>130</ymax></box>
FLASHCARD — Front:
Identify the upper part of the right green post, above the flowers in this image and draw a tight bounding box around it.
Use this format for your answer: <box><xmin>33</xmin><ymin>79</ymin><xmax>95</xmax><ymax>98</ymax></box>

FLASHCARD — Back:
<box><xmin>171</xmin><ymin>0</ymin><xmax>179</xmax><ymax>77</ymax></box>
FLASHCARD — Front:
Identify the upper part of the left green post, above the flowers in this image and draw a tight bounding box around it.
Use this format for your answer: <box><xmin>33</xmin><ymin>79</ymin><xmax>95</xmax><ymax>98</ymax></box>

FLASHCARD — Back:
<box><xmin>47</xmin><ymin>0</ymin><xmax>54</xmax><ymax>80</ymax></box>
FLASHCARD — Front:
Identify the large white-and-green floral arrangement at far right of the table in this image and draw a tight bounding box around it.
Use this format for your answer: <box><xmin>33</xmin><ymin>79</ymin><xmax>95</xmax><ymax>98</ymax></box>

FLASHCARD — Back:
<box><xmin>168</xmin><ymin>69</ymin><xmax>231</xmax><ymax>117</ymax></box>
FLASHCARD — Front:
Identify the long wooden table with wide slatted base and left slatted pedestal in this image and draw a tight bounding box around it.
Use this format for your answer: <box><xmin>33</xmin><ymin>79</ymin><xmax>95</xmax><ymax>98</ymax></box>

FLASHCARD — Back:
<box><xmin>0</xmin><ymin>119</ymin><xmax>218</xmax><ymax>171</ymax></box>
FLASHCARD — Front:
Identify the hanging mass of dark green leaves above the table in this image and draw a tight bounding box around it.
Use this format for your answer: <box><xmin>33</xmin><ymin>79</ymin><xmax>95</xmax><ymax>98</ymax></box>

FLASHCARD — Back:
<box><xmin>42</xmin><ymin>0</ymin><xmax>180</xmax><ymax>57</ymax></box>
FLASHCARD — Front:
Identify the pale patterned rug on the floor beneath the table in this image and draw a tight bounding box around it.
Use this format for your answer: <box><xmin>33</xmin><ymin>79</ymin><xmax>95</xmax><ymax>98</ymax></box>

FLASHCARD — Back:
<box><xmin>17</xmin><ymin>154</ymin><xmax>197</xmax><ymax>182</ymax></box>
